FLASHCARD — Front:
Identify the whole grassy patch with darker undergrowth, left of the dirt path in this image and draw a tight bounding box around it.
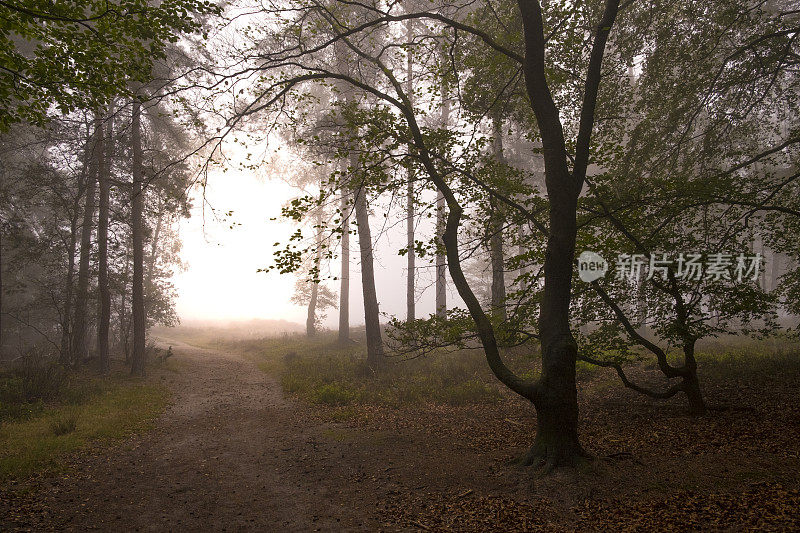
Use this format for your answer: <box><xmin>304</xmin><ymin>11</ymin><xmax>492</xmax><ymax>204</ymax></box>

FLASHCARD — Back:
<box><xmin>0</xmin><ymin>367</ymin><xmax>169</xmax><ymax>481</ymax></box>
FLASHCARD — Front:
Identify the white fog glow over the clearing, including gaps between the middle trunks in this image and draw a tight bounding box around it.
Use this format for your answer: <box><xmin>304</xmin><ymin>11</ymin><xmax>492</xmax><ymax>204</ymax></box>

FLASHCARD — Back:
<box><xmin>174</xmin><ymin>164</ymin><xmax>460</xmax><ymax>329</ymax></box>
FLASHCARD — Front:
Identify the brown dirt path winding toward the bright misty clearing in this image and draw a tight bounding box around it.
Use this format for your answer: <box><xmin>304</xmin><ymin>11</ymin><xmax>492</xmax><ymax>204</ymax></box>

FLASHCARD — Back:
<box><xmin>10</xmin><ymin>339</ymin><xmax>388</xmax><ymax>531</ymax></box>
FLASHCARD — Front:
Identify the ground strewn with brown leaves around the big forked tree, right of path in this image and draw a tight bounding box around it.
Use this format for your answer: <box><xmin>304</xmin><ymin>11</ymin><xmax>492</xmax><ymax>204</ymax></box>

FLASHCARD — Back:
<box><xmin>302</xmin><ymin>355</ymin><xmax>800</xmax><ymax>531</ymax></box>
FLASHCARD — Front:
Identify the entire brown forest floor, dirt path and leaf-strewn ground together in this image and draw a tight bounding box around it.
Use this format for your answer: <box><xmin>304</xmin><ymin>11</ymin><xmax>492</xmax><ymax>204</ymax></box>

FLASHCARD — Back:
<box><xmin>0</xmin><ymin>339</ymin><xmax>800</xmax><ymax>531</ymax></box>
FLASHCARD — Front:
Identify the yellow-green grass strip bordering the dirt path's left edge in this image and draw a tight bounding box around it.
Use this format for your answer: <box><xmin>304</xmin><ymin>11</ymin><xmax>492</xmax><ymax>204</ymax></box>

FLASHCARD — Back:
<box><xmin>0</xmin><ymin>375</ymin><xmax>168</xmax><ymax>481</ymax></box>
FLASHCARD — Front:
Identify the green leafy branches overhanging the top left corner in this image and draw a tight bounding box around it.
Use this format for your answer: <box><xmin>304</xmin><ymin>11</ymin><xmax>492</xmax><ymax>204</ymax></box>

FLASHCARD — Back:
<box><xmin>0</xmin><ymin>0</ymin><xmax>219</xmax><ymax>131</ymax></box>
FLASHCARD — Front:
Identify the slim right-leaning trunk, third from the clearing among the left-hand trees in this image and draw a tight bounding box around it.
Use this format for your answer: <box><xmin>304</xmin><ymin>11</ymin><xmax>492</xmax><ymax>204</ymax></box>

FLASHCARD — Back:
<box><xmin>71</xmin><ymin>120</ymin><xmax>103</xmax><ymax>366</ymax></box>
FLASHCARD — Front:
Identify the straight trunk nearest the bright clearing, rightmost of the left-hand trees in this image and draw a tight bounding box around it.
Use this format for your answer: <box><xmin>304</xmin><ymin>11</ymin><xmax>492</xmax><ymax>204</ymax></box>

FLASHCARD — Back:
<box><xmin>131</xmin><ymin>98</ymin><xmax>147</xmax><ymax>376</ymax></box>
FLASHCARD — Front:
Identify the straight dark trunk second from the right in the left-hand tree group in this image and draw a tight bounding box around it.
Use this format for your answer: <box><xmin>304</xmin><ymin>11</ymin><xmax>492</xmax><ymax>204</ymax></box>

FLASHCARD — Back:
<box><xmin>95</xmin><ymin>112</ymin><xmax>112</xmax><ymax>373</ymax></box>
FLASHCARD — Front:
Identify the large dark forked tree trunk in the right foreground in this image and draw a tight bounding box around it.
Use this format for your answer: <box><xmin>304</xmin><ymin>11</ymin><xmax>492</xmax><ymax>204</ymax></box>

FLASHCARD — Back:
<box><xmin>518</xmin><ymin>0</ymin><xmax>619</xmax><ymax>468</ymax></box>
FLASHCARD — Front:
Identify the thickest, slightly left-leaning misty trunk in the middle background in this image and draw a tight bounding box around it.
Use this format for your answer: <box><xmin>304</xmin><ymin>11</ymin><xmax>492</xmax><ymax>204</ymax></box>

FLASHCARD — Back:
<box><xmin>350</xmin><ymin>172</ymin><xmax>384</xmax><ymax>370</ymax></box>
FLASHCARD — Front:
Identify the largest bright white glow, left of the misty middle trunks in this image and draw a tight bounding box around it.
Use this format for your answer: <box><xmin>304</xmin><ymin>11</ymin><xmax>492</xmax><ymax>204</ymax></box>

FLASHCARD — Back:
<box><xmin>175</xmin><ymin>171</ymin><xmax>305</xmax><ymax>321</ymax></box>
